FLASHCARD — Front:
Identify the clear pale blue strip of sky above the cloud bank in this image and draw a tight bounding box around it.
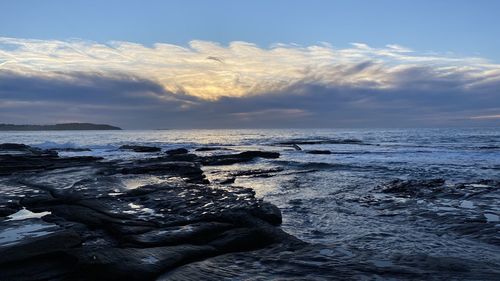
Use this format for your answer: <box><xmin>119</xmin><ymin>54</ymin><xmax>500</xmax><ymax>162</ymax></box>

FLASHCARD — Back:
<box><xmin>0</xmin><ymin>0</ymin><xmax>500</xmax><ymax>62</ymax></box>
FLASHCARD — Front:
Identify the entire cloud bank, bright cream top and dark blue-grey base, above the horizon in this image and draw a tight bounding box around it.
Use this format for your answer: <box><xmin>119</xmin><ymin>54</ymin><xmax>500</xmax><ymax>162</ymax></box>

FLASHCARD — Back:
<box><xmin>0</xmin><ymin>37</ymin><xmax>500</xmax><ymax>128</ymax></box>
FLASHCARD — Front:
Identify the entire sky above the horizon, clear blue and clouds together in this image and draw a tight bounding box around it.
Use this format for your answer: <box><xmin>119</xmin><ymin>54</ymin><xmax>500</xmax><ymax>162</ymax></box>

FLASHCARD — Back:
<box><xmin>0</xmin><ymin>0</ymin><xmax>500</xmax><ymax>129</ymax></box>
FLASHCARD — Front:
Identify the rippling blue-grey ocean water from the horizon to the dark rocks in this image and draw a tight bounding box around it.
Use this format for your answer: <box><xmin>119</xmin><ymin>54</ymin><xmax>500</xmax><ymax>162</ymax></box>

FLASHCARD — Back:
<box><xmin>0</xmin><ymin>128</ymin><xmax>500</xmax><ymax>276</ymax></box>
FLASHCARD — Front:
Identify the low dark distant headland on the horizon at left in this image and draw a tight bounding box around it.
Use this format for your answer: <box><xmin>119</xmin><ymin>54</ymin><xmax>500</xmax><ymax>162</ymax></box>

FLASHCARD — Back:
<box><xmin>0</xmin><ymin>123</ymin><xmax>121</xmax><ymax>131</ymax></box>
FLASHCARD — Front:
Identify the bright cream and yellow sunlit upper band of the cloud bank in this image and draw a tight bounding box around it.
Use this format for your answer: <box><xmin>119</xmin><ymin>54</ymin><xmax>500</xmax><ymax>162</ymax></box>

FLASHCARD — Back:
<box><xmin>0</xmin><ymin>38</ymin><xmax>500</xmax><ymax>100</ymax></box>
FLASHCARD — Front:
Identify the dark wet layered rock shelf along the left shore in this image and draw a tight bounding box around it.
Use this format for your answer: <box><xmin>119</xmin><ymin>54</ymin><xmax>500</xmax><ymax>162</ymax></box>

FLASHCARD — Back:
<box><xmin>0</xmin><ymin>144</ymin><xmax>307</xmax><ymax>280</ymax></box>
